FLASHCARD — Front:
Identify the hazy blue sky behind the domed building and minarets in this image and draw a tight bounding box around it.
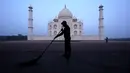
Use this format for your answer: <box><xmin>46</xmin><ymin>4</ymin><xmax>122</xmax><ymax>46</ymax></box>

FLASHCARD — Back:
<box><xmin>0</xmin><ymin>0</ymin><xmax>130</xmax><ymax>38</ymax></box>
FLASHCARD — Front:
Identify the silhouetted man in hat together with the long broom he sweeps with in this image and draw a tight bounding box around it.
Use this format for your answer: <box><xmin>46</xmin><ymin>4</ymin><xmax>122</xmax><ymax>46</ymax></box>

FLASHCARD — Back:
<box><xmin>21</xmin><ymin>21</ymin><xmax>71</xmax><ymax>65</ymax></box>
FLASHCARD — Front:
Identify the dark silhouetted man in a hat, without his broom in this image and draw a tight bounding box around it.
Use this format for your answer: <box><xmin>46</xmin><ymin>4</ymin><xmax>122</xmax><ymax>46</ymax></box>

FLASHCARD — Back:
<box><xmin>54</xmin><ymin>21</ymin><xmax>71</xmax><ymax>57</ymax></box>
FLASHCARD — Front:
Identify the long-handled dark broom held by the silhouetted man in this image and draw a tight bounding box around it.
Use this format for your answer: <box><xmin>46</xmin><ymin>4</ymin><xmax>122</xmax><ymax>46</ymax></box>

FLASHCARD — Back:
<box><xmin>22</xmin><ymin>31</ymin><xmax>61</xmax><ymax>65</ymax></box>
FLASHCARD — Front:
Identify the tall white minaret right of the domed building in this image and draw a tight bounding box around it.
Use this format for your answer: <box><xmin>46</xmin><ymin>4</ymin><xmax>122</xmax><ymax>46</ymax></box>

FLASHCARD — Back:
<box><xmin>99</xmin><ymin>5</ymin><xmax>104</xmax><ymax>40</ymax></box>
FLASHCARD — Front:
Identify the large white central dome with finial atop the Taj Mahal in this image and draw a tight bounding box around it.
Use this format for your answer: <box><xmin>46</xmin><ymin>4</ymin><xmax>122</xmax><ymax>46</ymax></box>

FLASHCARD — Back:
<box><xmin>58</xmin><ymin>5</ymin><xmax>73</xmax><ymax>18</ymax></box>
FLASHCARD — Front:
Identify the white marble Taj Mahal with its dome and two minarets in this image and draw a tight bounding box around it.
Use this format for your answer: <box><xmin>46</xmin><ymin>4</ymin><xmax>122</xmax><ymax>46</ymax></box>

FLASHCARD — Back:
<box><xmin>27</xmin><ymin>5</ymin><xmax>104</xmax><ymax>40</ymax></box>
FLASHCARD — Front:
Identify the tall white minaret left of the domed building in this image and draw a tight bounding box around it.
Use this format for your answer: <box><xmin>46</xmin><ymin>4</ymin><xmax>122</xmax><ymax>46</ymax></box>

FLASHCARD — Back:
<box><xmin>28</xmin><ymin>5</ymin><xmax>33</xmax><ymax>40</ymax></box>
